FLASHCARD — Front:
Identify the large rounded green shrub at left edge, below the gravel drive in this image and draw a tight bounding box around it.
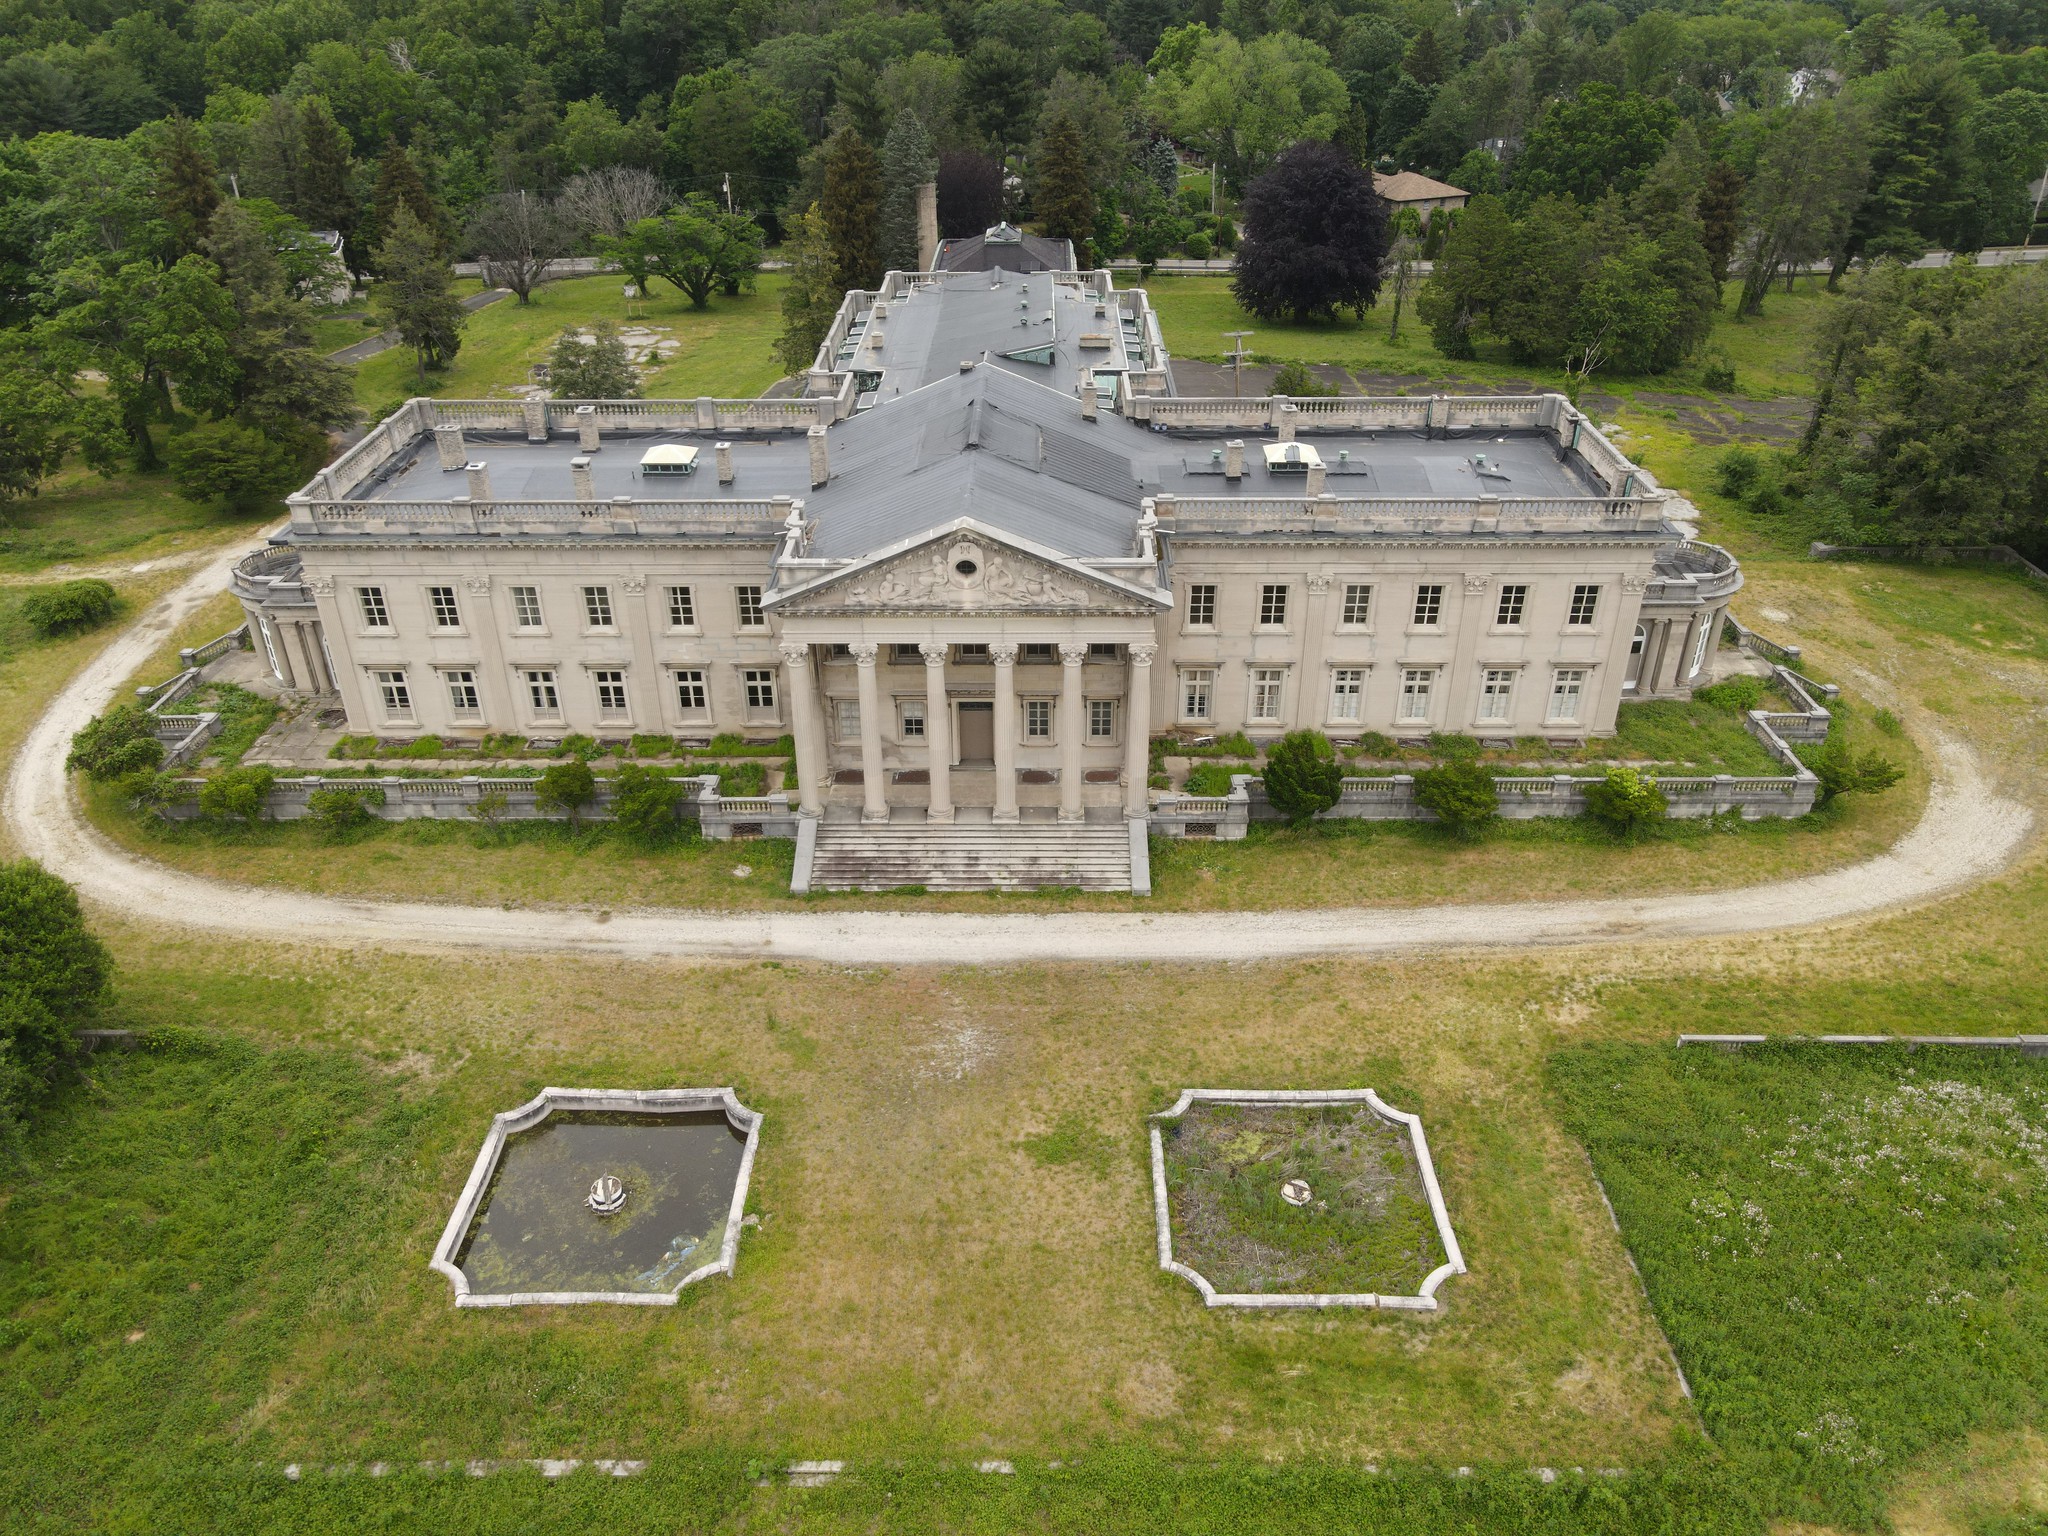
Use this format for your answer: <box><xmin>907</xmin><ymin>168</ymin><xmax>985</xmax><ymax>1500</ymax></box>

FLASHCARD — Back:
<box><xmin>0</xmin><ymin>858</ymin><xmax>113</xmax><ymax>1130</ymax></box>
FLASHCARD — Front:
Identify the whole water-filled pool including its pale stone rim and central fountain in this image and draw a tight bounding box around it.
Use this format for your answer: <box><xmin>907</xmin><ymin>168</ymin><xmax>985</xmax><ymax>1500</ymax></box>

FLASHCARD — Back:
<box><xmin>434</xmin><ymin>1087</ymin><xmax>760</xmax><ymax>1307</ymax></box>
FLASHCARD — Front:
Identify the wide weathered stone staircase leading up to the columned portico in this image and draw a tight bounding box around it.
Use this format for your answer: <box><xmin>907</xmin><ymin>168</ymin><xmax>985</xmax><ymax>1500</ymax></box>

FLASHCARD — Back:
<box><xmin>799</xmin><ymin>821</ymin><xmax>1149</xmax><ymax>891</ymax></box>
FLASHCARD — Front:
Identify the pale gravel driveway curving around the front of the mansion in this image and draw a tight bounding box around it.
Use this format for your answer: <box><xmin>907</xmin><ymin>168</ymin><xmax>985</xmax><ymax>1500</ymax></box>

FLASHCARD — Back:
<box><xmin>0</xmin><ymin>549</ymin><xmax>2034</xmax><ymax>965</ymax></box>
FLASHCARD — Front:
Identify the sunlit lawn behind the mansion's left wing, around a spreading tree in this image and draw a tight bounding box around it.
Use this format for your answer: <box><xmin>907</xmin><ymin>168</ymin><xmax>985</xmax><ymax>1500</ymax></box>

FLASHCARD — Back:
<box><xmin>356</xmin><ymin>272</ymin><xmax>784</xmax><ymax>414</ymax></box>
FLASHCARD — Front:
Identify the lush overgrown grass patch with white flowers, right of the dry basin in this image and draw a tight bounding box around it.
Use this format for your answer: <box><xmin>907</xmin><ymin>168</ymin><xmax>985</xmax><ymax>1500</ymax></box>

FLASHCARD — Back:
<box><xmin>1552</xmin><ymin>1044</ymin><xmax>2048</xmax><ymax>1526</ymax></box>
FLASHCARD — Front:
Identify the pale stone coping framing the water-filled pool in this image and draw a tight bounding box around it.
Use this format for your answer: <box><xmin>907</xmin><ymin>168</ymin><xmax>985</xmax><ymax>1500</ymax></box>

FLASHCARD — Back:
<box><xmin>432</xmin><ymin>1087</ymin><xmax>762</xmax><ymax>1307</ymax></box>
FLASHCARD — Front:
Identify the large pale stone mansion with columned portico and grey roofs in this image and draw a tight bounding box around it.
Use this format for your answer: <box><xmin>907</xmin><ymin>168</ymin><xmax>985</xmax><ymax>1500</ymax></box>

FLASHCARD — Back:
<box><xmin>233</xmin><ymin>266</ymin><xmax>1741</xmax><ymax>843</ymax></box>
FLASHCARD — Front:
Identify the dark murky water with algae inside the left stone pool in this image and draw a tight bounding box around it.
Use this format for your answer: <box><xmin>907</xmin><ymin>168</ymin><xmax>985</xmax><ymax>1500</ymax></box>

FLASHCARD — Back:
<box><xmin>455</xmin><ymin>1110</ymin><xmax>745</xmax><ymax>1296</ymax></box>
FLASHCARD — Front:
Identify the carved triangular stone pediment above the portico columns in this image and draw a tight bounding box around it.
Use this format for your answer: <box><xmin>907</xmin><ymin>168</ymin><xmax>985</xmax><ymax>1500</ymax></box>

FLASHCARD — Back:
<box><xmin>768</xmin><ymin>518</ymin><xmax>1171</xmax><ymax>618</ymax></box>
